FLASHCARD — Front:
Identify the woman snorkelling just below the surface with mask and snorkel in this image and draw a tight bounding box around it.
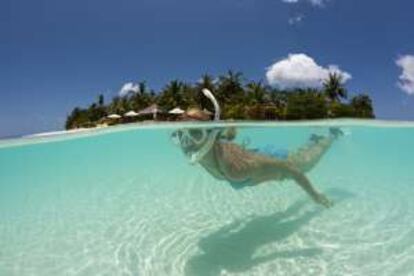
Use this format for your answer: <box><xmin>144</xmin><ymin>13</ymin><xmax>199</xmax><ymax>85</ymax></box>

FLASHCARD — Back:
<box><xmin>172</xmin><ymin>91</ymin><xmax>342</xmax><ymax>207</ymax></box>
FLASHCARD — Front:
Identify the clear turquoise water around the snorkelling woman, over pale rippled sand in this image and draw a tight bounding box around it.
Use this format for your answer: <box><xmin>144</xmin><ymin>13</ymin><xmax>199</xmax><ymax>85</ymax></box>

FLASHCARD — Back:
<box><xmin>0</xmin><ymin>121</ymin><xmax>414</xmax><ymax>276</ymax></box>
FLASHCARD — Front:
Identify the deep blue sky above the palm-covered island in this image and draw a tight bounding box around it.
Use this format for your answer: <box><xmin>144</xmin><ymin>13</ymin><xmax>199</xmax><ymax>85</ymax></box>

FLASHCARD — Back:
<box><xmin>0</xmin><ymin>0</ymin><xmax>414</xmax><ymax>136</ymax></box>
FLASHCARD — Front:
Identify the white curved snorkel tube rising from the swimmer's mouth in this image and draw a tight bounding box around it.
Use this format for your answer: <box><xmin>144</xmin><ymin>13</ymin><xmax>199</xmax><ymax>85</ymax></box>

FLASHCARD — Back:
<box><xmin>190</xmin><ymin>88</ymin><xmax>220</xmax><ymax>164</ymax></box>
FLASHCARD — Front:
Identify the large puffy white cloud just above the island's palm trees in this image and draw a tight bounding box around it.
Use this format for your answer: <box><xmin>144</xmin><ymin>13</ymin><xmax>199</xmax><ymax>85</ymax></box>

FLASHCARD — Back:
<box><xmin>266</xmin><ymin>54</ymin><xmax>352</xmax><ymax>89</ymax></box>
